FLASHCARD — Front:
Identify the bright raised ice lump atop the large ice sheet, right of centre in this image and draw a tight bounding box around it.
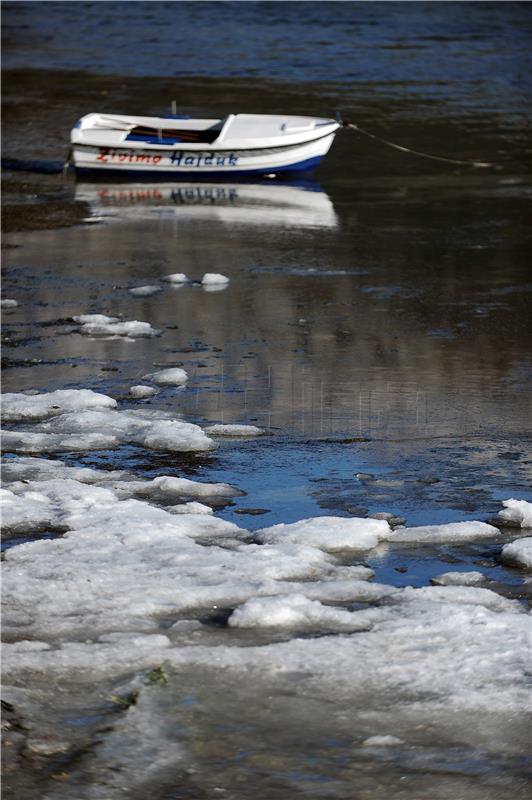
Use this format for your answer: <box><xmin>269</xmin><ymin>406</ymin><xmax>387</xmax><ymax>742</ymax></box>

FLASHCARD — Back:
<box><xmin>228</xmin><ymin>594</ymin><xmax>375</xmax><ymax>631</ymax></box>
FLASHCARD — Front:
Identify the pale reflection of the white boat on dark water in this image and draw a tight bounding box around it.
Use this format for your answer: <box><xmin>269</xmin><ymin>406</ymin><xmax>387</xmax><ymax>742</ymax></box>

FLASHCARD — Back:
<box><xmin>75</xmin><ymin>181</ymin><xmax>338</xmax><ymax>228</ymax></box>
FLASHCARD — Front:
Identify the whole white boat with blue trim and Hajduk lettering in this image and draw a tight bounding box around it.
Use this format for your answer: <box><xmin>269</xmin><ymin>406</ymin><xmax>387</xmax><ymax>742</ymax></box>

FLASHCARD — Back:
<box><xmin>70</xmin><ymin>114</ymin><xmax>342</xmax><ymax>178</ymax></box>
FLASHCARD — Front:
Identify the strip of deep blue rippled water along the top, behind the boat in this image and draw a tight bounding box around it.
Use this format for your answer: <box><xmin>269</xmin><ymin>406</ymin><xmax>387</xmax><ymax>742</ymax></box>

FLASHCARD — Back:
<box><xmin>3</xmin><ymin>2</ymin><xmax>532</xmax><ymax>116</ymax></box>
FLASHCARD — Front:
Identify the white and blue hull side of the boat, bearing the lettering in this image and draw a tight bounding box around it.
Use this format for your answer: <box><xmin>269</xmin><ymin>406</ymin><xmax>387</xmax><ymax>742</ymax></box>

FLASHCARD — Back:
<box><xmin>71</xmin><ymin>131</ymin><xmax>336</xmax><ymax>178</ymax></box>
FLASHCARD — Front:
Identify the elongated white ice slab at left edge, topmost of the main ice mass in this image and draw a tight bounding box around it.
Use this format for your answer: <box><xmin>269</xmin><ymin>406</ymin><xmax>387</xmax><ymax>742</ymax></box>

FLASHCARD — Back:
<box><xmin>1</xmin><ymin>389</ymin><xmax>117</xmax><ymax>421</ymax></box>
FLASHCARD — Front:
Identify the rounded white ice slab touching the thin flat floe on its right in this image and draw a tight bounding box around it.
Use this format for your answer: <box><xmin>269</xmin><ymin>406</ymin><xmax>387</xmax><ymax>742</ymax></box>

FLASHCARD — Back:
<box><xmin>256</xmin><ymin>517</ymin><xmax>390</xmax><ymax>553</ymax></box>
